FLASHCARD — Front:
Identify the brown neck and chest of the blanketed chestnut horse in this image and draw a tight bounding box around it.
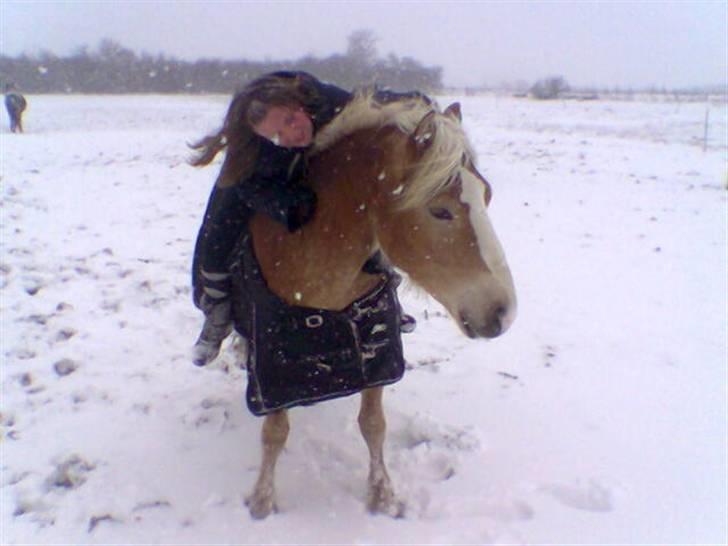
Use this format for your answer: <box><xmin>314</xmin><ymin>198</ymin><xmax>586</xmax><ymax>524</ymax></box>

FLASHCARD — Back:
<box><xmin>251</xmin><ymin>125</ymin><xmax>410</xmax><ymax>309</ymax></box>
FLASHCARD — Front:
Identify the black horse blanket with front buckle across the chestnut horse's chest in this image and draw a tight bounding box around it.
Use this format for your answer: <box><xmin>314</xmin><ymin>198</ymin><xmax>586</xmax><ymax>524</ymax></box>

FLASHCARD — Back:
<box><xmin>232</xmin><ymin>237</ymin><xmax>404</xmax><ymax>415</ymax></box>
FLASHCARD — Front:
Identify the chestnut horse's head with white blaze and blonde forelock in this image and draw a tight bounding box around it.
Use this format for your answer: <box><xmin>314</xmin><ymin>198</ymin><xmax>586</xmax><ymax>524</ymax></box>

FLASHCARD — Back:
<box><xmin>372</xmin><ymin>98</ymin><xmax>516</xmax><ymax>338</ymax></box>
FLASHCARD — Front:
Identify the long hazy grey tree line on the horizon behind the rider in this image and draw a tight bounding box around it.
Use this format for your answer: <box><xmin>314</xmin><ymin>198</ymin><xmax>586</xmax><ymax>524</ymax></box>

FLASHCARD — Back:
<box><xmin>0</xmin><ymin>30</ymin><xmax>443</xmax><ymax>94</ymax></box>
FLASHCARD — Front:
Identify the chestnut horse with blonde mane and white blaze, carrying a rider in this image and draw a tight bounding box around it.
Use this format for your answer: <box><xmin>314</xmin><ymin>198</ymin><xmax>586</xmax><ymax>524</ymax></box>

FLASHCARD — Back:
<box><xmin>237</xmin><ymin>93</ymin><xmax>516</xmax><ymax>518</ymax></box>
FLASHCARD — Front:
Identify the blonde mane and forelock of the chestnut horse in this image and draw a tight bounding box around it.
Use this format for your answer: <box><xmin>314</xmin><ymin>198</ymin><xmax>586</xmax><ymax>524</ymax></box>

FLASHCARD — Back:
<box><xmin>309</xmin><ymin>90</ymin><xmax>475</xmax><ymax>208</ymax></box>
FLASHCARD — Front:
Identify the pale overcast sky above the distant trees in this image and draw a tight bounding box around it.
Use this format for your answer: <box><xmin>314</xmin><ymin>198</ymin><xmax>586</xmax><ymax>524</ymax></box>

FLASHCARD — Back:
<box><xmin>0</xmin><ymin>0</ymin><xmax>728</xmax><ymax>88</ymax></box>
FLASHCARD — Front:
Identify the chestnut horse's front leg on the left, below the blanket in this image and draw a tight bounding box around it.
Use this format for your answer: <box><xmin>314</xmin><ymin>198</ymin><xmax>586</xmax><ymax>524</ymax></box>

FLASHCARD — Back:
<box><xmin>246</xmin><ymin>410</ymin><xmax>290</xmax><ymax>519</ymax></box>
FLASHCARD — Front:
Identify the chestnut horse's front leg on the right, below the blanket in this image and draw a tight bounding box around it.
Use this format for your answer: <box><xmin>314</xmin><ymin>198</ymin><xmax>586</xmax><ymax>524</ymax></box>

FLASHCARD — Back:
<box><xmin>359</xmin><ymin>387</ymin><xmax>405</xmax><ymax>518</ymax></box>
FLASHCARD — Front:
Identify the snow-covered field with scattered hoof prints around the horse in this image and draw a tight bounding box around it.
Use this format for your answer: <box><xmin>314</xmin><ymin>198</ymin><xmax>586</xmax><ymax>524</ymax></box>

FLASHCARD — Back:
<box><xmin>0</xmin><ymin>96</ymin><xmax>728</xmax><ymax>546</ymax></box>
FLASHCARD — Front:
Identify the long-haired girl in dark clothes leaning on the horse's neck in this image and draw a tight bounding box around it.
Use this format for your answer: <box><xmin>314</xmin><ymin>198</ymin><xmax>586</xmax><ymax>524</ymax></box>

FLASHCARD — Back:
<box><xmin>192</xmin><ymin>72</ymin><xmax>414</xmax><ymax>366</ymax></box>
